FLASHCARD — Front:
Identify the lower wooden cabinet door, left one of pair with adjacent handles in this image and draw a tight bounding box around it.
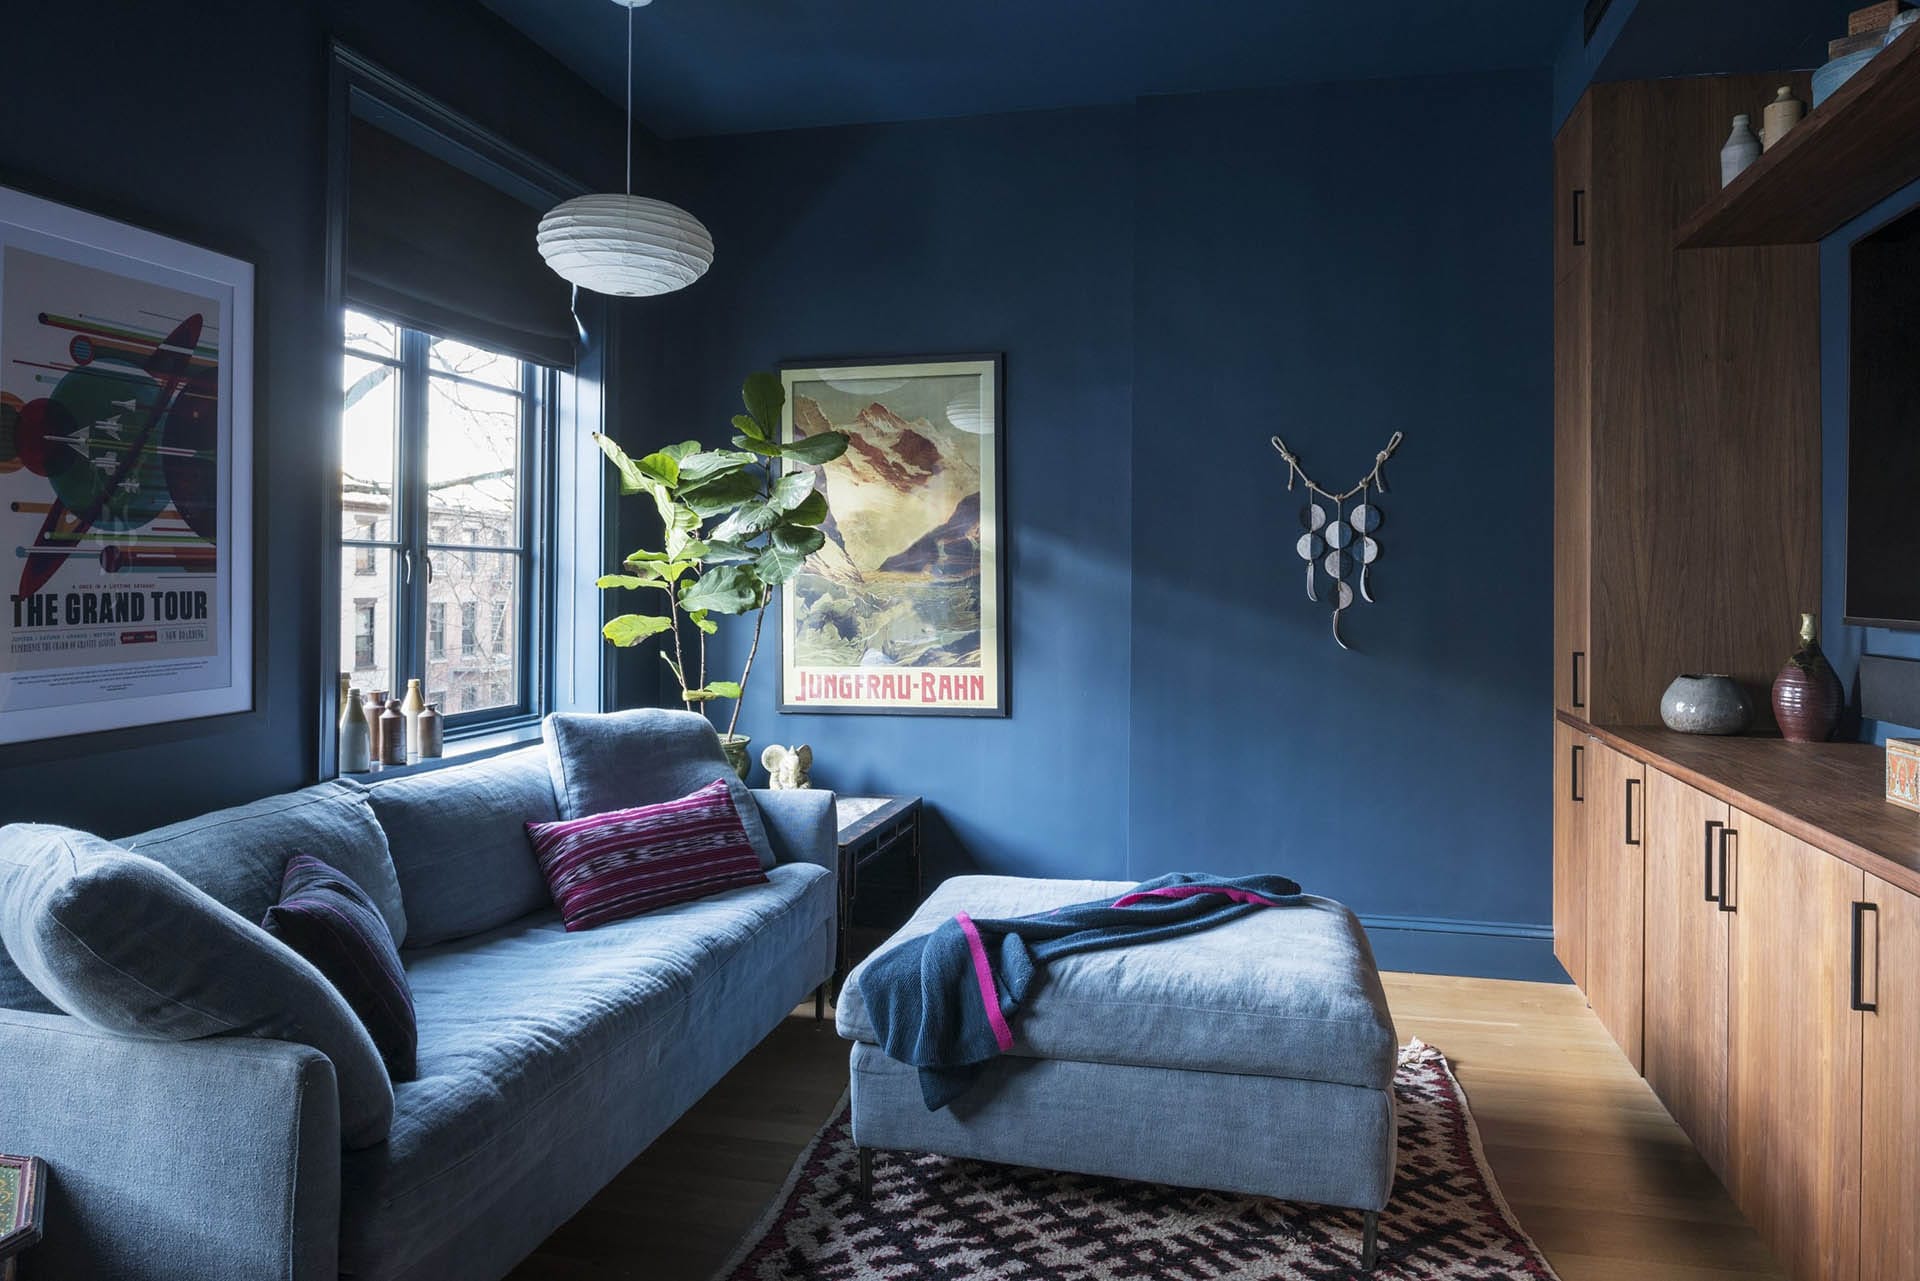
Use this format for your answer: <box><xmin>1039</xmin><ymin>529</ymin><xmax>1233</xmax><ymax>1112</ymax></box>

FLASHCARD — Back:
<box><xmin>1644</xmin><ymin>770</ymin><xmax>1730</xmax><ymax>1179</ymax></box>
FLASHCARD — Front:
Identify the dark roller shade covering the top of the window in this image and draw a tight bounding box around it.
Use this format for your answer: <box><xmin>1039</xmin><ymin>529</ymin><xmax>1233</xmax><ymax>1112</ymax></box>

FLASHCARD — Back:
<box><xmin>348</xmin><ymin>115</ymin><xmax>576</xmax><ymax>369</ymax></box>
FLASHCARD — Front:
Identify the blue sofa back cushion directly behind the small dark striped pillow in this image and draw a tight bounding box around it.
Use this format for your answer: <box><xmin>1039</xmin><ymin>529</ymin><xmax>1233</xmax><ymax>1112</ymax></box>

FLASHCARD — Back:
<box><xmin>121</xmin><ymin>780</ymin><xmax>407</xmax><ymax>943</ymax></box>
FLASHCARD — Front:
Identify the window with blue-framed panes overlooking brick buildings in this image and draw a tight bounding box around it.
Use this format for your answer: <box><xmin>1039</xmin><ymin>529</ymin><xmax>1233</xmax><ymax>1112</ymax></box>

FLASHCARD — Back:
<box><xmin>340</xmin><ymin>309</ymin><xmax>555</xmax><ymax>734</ymax></box>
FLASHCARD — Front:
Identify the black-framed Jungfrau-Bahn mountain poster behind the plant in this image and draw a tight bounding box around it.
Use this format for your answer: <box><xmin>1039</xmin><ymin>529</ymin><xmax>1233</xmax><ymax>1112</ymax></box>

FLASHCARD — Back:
<box><xmin>780</xmin><ymin>355</ymin><xmax>1008</xmax><ymax>716</ymax></box>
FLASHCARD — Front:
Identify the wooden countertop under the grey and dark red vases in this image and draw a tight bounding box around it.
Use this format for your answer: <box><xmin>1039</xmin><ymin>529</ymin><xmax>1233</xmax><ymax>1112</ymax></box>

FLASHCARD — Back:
<box><xmin>1557</xmin><ymin>713</ymin><xmax>1920</xmax><ymax>895</ymax></box>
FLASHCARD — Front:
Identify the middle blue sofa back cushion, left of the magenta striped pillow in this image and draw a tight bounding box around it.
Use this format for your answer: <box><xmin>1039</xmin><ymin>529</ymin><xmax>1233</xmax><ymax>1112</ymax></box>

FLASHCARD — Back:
<box><xmin>367</xmin><ymin>745</ymin><xmax>561</xmax><ymax>947</ymax></box>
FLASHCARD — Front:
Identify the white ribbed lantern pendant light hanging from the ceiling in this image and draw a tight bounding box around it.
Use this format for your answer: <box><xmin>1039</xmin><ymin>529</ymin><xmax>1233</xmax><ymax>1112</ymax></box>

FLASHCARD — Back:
<box><xmin>540</xmin><ymin>0</ymin><xmax>714</xmax><ymax>298</ymax></box>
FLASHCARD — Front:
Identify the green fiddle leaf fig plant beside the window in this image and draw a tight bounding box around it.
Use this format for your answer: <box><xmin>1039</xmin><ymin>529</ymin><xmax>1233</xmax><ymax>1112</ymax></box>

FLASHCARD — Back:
<box><xmin>593</xmin><ymin>373</ymin><xmax>847</xmax><ymax>739</ymax></box>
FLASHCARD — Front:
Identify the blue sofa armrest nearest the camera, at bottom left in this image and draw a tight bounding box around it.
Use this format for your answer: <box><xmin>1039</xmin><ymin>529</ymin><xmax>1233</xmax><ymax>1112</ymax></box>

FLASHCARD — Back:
<box><xmin>0</xmin><ymin>1010</ymin><xmax>340</xmax><ymax>1281</ymax></box>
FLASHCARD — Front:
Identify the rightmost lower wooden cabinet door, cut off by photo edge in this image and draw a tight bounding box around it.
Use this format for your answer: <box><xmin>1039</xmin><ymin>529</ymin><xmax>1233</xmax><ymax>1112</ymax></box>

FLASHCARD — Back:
<box><xmin>1859</xmin><ymin>876</ymin><xmax>1920</xmax><ymax>1281</ymax></box>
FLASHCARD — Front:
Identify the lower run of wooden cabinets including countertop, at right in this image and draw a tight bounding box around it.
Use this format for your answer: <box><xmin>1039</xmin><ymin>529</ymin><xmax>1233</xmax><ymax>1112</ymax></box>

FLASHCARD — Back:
<box><xmin>1555</xmin><ymin>722</ymin><xmax>1920</xmax><ymax>1281</ymax></box>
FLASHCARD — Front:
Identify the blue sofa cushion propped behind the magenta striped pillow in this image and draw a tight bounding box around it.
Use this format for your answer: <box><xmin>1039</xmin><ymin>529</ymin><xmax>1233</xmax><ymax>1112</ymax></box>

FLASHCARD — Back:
<box><xmin>541</xmin><ymin>707</ymin><xmax>774</xmax><ymax>868</ymax></box>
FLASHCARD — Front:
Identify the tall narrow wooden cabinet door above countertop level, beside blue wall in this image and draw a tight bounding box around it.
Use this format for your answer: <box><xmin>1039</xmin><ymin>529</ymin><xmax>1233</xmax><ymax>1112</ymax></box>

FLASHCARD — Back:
<box><xmin>1553</xmin><ymin>100</ymin><xmax>1594</xmax><ymax>716</ymax></box>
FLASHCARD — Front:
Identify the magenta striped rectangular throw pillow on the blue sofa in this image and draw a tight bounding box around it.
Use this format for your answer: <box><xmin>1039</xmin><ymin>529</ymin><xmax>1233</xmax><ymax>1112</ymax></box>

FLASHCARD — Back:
<box><xmin>526</xmin><ymin>780</ymin><xmax>766</xmax><ymax>931</ymax></box>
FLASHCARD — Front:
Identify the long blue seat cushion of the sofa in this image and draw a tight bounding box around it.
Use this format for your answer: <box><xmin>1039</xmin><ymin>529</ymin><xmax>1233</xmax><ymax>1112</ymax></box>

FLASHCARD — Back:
<box><xmin>340</xmin><ymin>866</ymin><xmax>833</xmax><ymax>1277</ymax></box>
